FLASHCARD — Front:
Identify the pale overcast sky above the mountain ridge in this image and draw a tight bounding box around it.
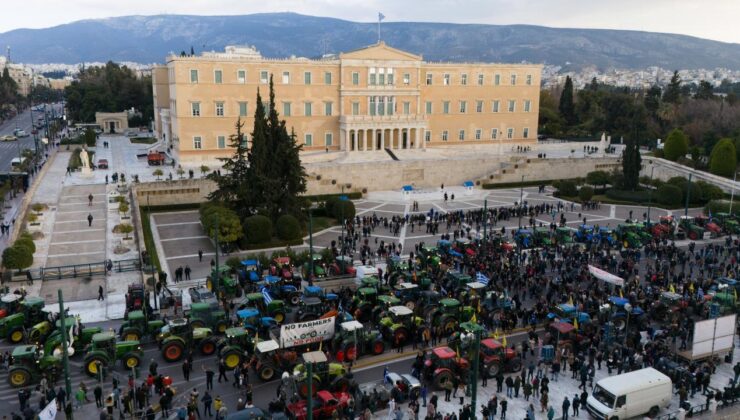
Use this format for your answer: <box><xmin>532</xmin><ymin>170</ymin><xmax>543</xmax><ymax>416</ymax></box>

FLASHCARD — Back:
<box><xmin>5</xmin><ymin>0</ymin><xmax>740</xmax><ymax>43</ymax></box>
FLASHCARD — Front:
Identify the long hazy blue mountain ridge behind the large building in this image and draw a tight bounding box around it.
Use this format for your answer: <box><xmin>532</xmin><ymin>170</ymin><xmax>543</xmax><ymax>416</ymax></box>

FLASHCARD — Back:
<box><xmin>0</xmin><ymin>13</ymin><xmax>740</xmax><ymax>70</ymax></box>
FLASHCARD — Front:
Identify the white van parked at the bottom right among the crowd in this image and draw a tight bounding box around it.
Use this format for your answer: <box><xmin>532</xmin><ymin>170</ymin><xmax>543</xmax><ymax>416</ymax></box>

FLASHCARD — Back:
<box><xmin>586</xmin><ymin>368</ymin><xmax>673</xmax><ymax>420</ymax></box>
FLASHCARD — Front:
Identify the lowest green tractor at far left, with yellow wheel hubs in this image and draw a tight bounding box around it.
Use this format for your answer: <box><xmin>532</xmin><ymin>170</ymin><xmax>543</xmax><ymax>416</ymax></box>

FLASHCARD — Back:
<box><xmin>8</xmin><ymin>344</ymin><xmax>62</xmax><ymax>388</ymax></box>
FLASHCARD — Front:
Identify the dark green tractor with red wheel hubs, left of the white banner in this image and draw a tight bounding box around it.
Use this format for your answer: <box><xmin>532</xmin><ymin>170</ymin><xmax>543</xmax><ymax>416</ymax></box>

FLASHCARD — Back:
<box><xmin>157</xmin><ymin>318</ymin><xmax>216</xmax><ymax>363</ymax></box>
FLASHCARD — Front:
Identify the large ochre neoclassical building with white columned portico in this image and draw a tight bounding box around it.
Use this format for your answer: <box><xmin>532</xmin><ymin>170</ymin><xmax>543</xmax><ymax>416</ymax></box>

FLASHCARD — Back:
<box><xmin>152</xmin><ymin>42</ymin><xmax>542</xmax><ymax>163</ymax></box>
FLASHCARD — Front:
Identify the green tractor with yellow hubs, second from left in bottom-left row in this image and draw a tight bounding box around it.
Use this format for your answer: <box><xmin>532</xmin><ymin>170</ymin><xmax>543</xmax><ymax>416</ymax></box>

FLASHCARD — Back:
<box><xmin>83</xmin><ymin>331</ymin><xmax>144</xmax><ymax>376</ymax></box>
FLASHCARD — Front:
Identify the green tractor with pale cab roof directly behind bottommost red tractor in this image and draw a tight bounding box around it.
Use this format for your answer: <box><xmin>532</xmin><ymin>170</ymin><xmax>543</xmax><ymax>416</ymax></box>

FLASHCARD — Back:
<box><xmin>293</xmin><ymin>351</ymin><xmax>352</xmax><ymax>398</ymax></box>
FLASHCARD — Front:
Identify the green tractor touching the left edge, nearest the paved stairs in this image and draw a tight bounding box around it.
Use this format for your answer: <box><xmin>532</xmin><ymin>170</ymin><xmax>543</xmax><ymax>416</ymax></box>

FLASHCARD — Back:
<box><xmin>0</xmin><ymin>297</ymin><xmax>52</xmax><ymax>344</ymax></box>
